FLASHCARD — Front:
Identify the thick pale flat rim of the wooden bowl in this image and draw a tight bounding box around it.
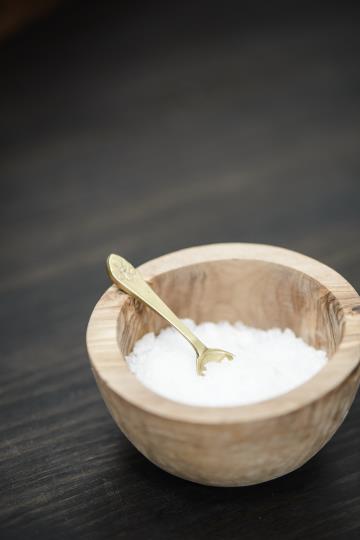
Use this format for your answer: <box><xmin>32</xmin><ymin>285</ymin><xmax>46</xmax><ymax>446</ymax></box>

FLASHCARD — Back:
<box><xmin>86</xmin><ymin>243</ymin><xmax>360</xmax><ymax>424</ymax></box>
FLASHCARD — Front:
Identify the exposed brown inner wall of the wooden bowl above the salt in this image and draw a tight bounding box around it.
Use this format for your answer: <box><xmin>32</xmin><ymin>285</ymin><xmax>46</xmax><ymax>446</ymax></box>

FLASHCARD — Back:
<box><xmin>117</xmin><ymin>259</ymin><xmax>344</xmax><ymax>357</ymax></box>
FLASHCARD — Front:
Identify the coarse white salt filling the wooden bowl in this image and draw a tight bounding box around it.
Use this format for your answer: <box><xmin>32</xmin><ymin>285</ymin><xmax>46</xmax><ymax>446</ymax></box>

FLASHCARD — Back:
<box><xmin>127</xmin><ymin>319</ymin><xmax>327</xmax><ymax>407</ymax></box>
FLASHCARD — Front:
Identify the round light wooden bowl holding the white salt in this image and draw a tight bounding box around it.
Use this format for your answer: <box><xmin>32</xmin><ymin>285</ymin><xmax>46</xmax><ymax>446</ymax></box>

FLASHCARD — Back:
<box><xmin>87</xmin><ymin>244</ymin><xmax>360</xmax><ymax>486</ymax></box>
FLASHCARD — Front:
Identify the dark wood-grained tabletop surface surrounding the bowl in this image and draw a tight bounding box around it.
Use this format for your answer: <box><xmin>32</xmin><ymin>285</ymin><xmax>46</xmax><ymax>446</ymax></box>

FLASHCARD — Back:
<box><xmin>0</xmin><ymin>2</ymin><xmax>360</xmax><ymax>540</ymax></box>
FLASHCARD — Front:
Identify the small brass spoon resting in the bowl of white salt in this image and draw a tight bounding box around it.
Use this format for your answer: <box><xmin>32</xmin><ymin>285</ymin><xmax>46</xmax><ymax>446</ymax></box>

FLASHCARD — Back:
<box><xmin>107</xmin><ymin>254</ymin><xmax>234</xmax><ymax>375</ymax></box>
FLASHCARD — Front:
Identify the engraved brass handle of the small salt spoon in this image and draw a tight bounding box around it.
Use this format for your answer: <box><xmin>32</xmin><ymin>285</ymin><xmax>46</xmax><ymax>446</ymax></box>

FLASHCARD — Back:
<box><xmin>106</xmin><ymin>254</ymin><xmax>206</xmax><ymax>356</ymax></box>
